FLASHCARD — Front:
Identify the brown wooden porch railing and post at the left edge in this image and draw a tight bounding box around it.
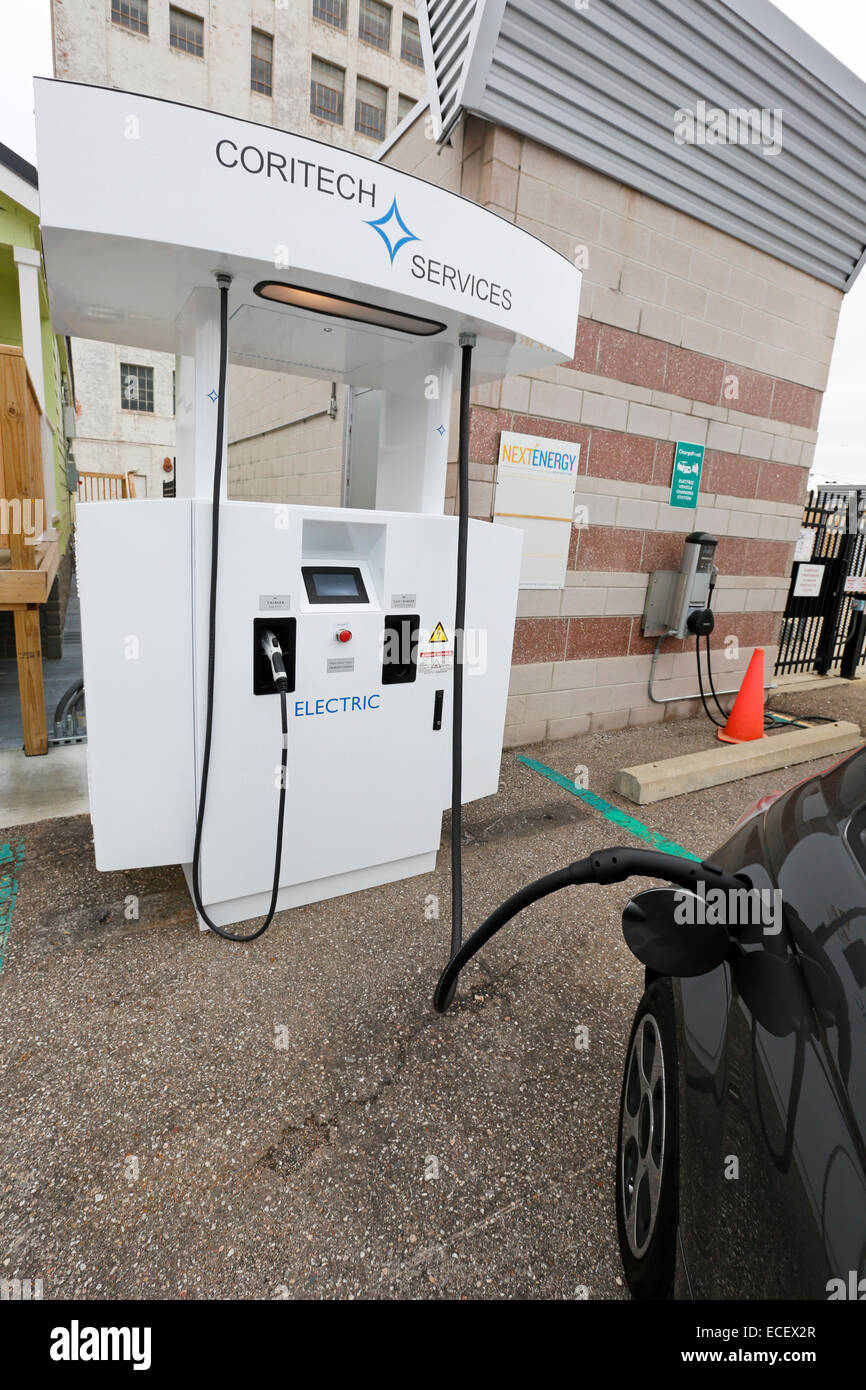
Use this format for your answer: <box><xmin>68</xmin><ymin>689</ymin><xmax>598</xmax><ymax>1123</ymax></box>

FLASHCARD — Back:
<box><xmin>0</xmin><ymin>343</ymin><xmax>60</xmax><ymax>755</ymax></box>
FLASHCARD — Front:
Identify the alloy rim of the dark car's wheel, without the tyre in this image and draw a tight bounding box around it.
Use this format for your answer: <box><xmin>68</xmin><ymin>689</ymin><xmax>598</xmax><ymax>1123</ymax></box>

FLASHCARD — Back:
<box><xmin>620</xmin><ymin>1013</ymin><xmax>667</xmax><ymax>1259</ymax></box>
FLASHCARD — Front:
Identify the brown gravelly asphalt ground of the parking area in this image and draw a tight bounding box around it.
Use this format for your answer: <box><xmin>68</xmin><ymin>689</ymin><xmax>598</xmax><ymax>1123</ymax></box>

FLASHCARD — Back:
<box><xmin>0</xmin><ymin>682</ymin><xmax>866</xmax><ymax>1298</ymax></box>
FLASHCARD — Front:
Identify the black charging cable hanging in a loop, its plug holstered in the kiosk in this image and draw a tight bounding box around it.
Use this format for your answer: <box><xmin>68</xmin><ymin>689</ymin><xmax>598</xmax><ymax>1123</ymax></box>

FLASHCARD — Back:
<box><xmin>192</xmin><ymin>275</ymin><xmax>289</xmax><ymax>941</ymax></box>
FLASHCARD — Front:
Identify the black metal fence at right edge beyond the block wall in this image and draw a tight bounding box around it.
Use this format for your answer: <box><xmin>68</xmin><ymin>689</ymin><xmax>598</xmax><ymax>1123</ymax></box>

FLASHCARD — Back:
<box><xmin>776</xmin><ymin>485</ymin><xmax>866</xmax><ymax>676</ymax></box>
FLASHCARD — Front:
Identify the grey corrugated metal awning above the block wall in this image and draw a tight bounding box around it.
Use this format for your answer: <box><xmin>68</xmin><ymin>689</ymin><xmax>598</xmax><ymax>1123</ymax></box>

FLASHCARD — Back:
<box><xmin>418</xmin><ymin>0</ymin><xmax>866</xmax><ymax>289</ymax></box>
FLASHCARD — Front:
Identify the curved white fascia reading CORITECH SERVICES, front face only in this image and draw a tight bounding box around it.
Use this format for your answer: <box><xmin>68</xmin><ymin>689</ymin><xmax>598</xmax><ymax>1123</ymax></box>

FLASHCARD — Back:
<box><xmin>36</xmin><ymin>79</ymin><xmax>580</xmax><ymax>354</ymax></box>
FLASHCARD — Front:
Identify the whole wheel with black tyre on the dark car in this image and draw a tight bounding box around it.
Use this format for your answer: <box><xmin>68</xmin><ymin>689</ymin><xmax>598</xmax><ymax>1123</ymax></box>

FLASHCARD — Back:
<box><xmin>616</xmin><ymin>980</ymin><xmax>678</xmax><ymax>1298</ymax></box>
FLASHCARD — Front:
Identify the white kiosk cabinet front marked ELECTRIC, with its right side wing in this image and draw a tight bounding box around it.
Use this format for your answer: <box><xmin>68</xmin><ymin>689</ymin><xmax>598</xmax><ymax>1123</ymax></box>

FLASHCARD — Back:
<box><xmin>187</xmin><ymin>503</ymin><xmax>520</xmax><ymax>905</ymax></box>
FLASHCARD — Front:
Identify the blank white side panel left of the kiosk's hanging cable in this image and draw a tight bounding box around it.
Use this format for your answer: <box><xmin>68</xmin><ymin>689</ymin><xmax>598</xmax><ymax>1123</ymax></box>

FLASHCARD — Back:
<box><xmin>76</xmin><ymin>499</ymin><xmax>195</xmax><ymax>870</ymax></box>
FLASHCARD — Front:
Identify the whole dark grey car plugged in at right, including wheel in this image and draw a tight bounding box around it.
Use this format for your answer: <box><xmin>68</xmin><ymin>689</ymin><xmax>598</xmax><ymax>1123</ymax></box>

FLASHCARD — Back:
<box><xmin>616</xmin><ymin>748</ymin><xmax>866</xmax><ymax>1300</ymax></box>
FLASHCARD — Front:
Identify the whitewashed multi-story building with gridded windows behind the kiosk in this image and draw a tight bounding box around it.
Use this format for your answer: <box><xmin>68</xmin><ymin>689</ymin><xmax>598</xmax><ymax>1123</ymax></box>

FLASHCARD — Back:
<box><xmin>51</xmin><ymin>0</ymin><xmax>425</xmax><ymax>503</ymax></box>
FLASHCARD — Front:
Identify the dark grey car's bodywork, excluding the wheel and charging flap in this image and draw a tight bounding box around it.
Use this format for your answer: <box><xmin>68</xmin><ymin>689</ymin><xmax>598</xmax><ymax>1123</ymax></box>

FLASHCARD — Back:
<box><xmin>674</xmin><ymin>749</ymin><xmax>866</xmax><ymax>1298</ymax></box>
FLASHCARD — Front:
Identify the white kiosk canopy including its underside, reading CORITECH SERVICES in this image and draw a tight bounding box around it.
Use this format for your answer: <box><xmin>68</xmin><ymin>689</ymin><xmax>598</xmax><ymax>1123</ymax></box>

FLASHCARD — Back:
<box><xmin>36</xmin><ymin>79</ymin><xmax>580</xmax><ymax>386</ymax></box>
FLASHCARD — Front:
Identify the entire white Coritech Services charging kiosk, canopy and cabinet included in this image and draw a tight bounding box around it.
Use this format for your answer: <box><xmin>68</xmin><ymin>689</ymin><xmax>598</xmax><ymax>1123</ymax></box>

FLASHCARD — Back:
<box><xmin>36</xmin><ymin>79</ymin><xmax>580</xmax><ymax>924</ymax></box>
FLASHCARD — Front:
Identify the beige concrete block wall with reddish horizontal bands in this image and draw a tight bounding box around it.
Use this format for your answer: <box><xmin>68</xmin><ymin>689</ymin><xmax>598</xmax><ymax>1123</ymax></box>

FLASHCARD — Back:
<box><xmin>386</xmin><ymin>118</ymin><xmax>841</xmax><ymax>745</ymax></box>
